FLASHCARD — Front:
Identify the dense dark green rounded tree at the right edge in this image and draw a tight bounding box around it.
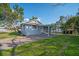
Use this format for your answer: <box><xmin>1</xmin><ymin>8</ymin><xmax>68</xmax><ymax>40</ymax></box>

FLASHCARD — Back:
<box><xmin>64</xmin><ymin>16</ymin><xmax>79</xmax><ymax>33</ymax></box>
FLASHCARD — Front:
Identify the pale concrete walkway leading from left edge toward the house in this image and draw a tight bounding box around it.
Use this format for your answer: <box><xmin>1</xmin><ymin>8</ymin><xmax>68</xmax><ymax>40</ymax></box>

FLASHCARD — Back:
<box><xmin>0</xmin><ymin>34</ymin><xmax>54</xmax><ymax>50</ymax></box>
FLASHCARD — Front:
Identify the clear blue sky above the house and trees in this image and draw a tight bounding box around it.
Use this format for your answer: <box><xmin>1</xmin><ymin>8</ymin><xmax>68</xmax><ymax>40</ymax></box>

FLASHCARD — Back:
<box><xmin>11</xmin><ymin>3</ymin><xmax>79</xmax><ymax>24</ymax></box>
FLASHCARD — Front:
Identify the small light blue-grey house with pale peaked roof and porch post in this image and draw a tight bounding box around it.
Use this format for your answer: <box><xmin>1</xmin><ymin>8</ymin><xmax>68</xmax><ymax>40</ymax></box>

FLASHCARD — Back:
<box><xmin>21</xmin><ymin>19</ymin><xmax>50</xmax><ymax>36</ymax></box>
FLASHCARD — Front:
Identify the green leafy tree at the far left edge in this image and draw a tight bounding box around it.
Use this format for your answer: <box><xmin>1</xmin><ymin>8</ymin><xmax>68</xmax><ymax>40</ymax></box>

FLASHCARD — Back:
<box><xmin>0</xmin><ymin>3</ymin><xmax>11</xmax><ymax>25</ymax></box>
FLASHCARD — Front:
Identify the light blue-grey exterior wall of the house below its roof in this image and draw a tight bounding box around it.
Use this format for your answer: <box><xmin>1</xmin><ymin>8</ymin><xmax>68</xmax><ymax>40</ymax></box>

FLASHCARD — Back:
<box><xmin>21</xmin><ymin>25</ymin><xmax>41</xmax><ymax>35</ymax></box>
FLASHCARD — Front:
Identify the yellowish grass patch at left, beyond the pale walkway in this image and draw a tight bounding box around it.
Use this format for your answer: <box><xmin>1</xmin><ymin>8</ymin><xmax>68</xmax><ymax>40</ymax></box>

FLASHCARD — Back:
<box><xmin>0</xmin><ymin>32</ymin><xmax>20</xmax><ymax>39</ymax></box>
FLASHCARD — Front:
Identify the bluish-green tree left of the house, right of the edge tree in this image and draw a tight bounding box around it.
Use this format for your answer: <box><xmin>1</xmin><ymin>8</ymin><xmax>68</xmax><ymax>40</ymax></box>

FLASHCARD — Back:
<box><xmin>12</xmin><ymin>4</ymin><xmax>24</xmax><ymax>31</ymax></box>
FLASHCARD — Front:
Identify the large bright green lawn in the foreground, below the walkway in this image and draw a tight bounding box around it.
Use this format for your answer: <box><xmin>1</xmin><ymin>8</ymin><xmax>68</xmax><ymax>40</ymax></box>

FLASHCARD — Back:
<box><xmin>2</xmin><ymin>35</ymin><xmax>79</xmax><ymax>56</ymax></box>
